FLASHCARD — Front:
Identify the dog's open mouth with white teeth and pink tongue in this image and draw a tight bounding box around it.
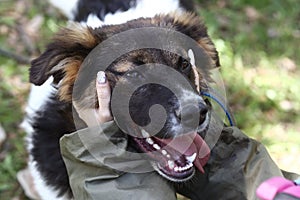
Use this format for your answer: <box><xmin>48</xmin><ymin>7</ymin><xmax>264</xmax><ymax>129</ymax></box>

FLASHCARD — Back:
<box><xmin>134</xmin><ymin>129</ymin><xmax>210</xmax><ymax>182</ymax></box>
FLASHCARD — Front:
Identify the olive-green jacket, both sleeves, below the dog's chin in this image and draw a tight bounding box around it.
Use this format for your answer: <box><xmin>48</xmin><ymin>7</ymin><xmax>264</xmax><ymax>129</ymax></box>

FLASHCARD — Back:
<box><xmin>60</xmin><ymin>122</ymin><xmax>299</xmax><ymax>200</ymax></box>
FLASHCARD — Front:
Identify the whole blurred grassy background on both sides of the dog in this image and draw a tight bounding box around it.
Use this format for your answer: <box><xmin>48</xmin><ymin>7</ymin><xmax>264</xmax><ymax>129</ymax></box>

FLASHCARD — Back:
<box><xmin>0</xmin><ymin>0</ymin><xmax>300</xmax><ymax>200</ymax></box>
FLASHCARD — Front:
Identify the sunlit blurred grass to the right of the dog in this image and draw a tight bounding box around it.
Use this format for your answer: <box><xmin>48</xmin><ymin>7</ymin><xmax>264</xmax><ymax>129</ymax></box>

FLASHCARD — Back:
<box><xmin>200</xmin><ymin>0</ymin><xmax>300</xmax><ymax>173</ymax></box>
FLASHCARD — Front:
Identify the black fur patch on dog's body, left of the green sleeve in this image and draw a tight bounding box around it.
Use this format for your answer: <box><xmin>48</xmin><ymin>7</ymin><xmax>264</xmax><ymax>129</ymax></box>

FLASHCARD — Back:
<box><xmin>30</xmin><ymin>95</ymin><xmax>76</xmax><ymax>196</ymax></box>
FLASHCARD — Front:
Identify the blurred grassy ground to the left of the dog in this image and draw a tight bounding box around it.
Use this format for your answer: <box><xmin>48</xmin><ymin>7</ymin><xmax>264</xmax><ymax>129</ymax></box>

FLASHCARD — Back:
<box><xmin>0</xmin><ymin>0</ymin><xmax>66</xmax><ymax>200</ymax></box>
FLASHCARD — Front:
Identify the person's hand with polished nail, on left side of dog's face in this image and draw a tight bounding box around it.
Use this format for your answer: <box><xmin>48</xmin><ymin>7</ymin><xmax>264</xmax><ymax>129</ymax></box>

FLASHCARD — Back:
<box><xmin>73</xmin><ymin>71</ymin><xmax>113</xmax><ymax>127</ymax></box>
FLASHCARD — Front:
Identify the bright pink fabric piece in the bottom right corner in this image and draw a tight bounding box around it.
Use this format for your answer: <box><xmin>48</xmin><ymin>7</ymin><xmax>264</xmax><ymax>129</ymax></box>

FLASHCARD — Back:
<box><xmin>256</xmin><ymin>177</ymin><xmax>295</xmax><ymax>200</ymax></box>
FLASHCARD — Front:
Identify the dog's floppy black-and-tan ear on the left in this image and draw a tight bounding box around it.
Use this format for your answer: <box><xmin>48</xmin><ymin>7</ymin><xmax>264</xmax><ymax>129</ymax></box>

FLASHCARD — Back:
<box><xmin>30</xmin><ymin>23</ymin><xmax>99</xmax><ymax>101</ymax></box>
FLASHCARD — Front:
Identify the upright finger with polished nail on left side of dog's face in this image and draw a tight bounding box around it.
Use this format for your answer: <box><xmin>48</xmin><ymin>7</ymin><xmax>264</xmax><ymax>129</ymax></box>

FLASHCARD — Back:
<box><xmin>96</xmin><ymin>71</ymin><xmax>112</xmax><ymax>122</ymax></box>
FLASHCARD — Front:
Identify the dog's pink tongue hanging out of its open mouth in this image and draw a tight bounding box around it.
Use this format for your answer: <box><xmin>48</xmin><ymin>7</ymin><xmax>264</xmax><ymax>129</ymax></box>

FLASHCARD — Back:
<box><xmin>156</xmin><ymin>132</ymin><xmax>210</xmax><ymax>173</ymax></box>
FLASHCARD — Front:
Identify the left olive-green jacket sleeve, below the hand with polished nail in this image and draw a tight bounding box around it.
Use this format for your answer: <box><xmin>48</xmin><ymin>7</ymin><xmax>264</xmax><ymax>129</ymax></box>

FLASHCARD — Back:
<box><xmin>60</xmin><ymin>122</ymin><xmax>176</xmax><ymax>200</ymax></box>
